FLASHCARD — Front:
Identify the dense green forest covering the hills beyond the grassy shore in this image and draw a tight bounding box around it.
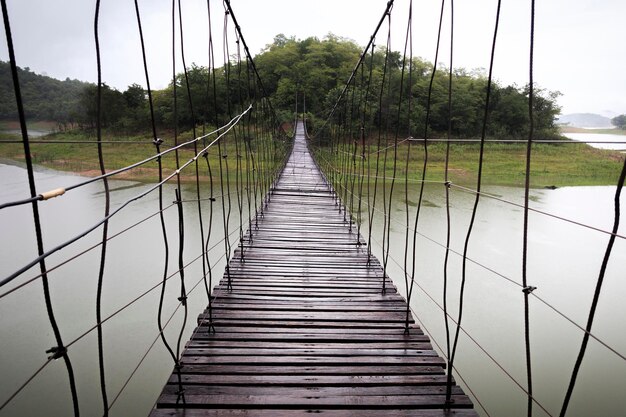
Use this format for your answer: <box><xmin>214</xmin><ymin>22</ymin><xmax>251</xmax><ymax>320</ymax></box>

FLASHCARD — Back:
<box><xmin>0</xmin><ymin>35</ymin><xmax>560</xmax><ymax>139</ymax></box>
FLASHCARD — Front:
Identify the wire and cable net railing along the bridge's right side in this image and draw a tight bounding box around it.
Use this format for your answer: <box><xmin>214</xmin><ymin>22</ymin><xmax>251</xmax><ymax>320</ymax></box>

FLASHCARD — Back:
<box><xmin>310</xmin><ymin>1</ymin><xmax>626</xmax><ymax>416</ymax></box>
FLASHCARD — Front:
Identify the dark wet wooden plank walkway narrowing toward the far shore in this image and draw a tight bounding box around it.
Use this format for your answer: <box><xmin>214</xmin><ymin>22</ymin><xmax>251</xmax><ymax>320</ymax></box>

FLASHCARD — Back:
<box><xmin>150</xmin><ymin>122</ymin><xmax>477</xmax><ymax>417</ymax></box>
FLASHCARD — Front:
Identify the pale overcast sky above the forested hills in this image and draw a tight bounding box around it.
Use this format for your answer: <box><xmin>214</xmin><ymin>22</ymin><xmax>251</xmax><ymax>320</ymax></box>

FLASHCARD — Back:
<box><xmin>0</xmin><ymin>0</ymin><xmax>626</xmax><ymax>117</ymax></box>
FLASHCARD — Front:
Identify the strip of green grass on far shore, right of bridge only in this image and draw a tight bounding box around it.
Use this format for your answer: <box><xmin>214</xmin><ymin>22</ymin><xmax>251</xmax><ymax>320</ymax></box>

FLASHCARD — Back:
<box><xmin>312</xmin><ymin>141</ymin><xmax>625</xmax><ymax>188</ymax></box>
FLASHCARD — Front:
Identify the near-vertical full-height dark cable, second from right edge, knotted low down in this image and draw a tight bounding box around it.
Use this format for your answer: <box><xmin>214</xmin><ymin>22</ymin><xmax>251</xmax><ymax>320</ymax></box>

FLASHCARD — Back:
<box><xmin>522</xmin><ymin>0</ymin><xmax>535</xmax><ymax>417</ymax></box>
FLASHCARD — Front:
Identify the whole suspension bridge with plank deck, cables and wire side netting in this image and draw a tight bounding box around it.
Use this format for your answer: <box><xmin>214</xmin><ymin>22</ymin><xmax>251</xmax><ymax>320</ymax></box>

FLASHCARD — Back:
<box><xmin>0</xmin><ymin>0</ymin><xmax>626</xmax><ymax>417</ymax></box>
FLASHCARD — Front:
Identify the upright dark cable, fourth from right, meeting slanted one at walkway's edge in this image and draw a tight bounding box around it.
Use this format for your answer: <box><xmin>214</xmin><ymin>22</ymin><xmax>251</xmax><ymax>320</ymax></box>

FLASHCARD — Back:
<box><xmin>443</xmin><ymin>0</ymin><xmax>454</xmax><ymax>407</ymax></box>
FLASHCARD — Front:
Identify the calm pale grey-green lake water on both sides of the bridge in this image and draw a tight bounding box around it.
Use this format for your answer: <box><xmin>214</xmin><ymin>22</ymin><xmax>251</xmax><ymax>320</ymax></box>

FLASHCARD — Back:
<box><xmin>0</xmin><ymin>161</ymin><xmax>626</xmax><ymax>417</ymax></box>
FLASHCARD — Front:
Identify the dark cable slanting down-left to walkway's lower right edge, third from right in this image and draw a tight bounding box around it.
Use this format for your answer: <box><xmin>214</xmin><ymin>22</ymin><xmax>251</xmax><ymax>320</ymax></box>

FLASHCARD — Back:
<box><xmin>448</xmin><ymin>0</ymin><xmax>502</xmax><ymax>404</ymax></box>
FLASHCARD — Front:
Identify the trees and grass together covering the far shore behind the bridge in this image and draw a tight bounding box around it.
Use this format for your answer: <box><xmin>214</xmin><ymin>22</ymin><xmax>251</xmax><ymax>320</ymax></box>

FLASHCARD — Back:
<box><xmin>0</xmin><ymin>35</ymin><xmax>624</xmax><ymax>187</ymax></box>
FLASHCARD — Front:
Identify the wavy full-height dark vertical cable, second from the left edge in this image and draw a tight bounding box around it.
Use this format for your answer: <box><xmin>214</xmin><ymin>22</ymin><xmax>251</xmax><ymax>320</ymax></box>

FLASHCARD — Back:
<box><xmin>94</xmin><ymin>0</ymin><xmax>111</xmax><ymax>416</ymax></box>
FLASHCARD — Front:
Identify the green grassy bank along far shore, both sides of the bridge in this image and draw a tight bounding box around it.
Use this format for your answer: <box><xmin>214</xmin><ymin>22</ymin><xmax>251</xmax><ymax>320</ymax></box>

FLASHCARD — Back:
<box><xmin>0</xmin><ymin>132</ymin><xmax>625</xmax><ymax>187</ymax></box>
